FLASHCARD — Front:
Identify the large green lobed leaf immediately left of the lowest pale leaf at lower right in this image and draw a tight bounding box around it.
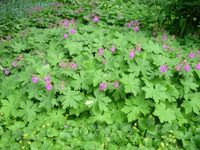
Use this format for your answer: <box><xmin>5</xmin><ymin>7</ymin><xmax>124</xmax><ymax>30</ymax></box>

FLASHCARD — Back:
<box><xmin>122</xmin><ymin>96</ymin><xmax>150</xmax><ymax>122</ymax></box>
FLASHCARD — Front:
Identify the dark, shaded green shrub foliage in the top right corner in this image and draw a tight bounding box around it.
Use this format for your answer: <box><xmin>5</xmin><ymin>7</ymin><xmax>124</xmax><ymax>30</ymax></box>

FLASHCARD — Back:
<box><xmin>155</xmin><ymin>0</ymin><xmax>200</xmax><ymax>38</ymax></box>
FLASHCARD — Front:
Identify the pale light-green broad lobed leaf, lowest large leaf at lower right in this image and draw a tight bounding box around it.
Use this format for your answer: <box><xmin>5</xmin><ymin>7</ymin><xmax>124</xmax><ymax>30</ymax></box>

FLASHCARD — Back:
<box><xmin>153</xmin><ymin>103</ymin><xmax>176</xmax><ymax>123</ymax></box>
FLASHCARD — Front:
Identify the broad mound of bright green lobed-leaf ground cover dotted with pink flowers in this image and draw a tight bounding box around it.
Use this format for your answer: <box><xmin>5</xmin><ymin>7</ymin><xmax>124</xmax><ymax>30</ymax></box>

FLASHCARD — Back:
<box><xmin>0</xmin><ymin>0</ymin><xmax>200</xmax><ymax>150</ymax></box>
